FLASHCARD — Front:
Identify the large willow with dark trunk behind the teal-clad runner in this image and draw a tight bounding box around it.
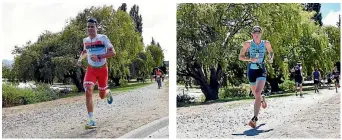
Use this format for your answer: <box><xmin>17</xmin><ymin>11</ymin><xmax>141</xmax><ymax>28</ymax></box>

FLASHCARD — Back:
<box><xmin>177</xmin><ymin>4</ymin><xmax>339</xmax><ymax>101</ymax></box>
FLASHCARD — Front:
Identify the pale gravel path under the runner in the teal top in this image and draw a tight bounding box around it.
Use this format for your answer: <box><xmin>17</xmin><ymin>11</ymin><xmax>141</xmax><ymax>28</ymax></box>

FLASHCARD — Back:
<box><xmin>177</xmin><ymin>90</ymin><xmax>341</xmax><ymax>138</ymax></box>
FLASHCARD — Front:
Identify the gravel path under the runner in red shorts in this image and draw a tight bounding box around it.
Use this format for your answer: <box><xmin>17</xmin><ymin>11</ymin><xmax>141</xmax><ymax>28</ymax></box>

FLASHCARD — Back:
<box><xmin>2</xmin><ymin>83</ymin><xmax>169</xmax><ymax>138</ymax></box>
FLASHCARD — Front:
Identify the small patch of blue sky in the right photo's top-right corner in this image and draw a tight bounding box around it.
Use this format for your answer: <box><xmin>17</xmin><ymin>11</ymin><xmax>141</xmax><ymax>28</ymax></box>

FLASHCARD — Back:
<box><xmin>321</xmin><ymin>3</ymin><xmax>341</xmax><ymax>25</ymax></box>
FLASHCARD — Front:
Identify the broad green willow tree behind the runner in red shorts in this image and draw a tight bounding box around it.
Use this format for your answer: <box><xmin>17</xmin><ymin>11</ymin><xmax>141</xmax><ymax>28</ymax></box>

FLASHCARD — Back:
<box><xmin>13</xmin><ymin>6</ymin><xmax>150</xmax><ymax>92</ymax></box>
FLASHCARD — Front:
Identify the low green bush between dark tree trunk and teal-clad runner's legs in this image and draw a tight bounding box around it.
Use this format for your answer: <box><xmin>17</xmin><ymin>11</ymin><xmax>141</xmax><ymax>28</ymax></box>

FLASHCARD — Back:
<box><xmin>219</xmin><ymin>84</ymin><xmax>250</xmax><ymax>99</ymax></box>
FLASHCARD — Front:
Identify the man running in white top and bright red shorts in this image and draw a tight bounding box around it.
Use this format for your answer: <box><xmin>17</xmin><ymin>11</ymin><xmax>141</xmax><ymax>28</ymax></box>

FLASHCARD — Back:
<box><xmin>77</xmin><ymin>18</ymin><xmax>116</xmax><ymax>129</ymax></box>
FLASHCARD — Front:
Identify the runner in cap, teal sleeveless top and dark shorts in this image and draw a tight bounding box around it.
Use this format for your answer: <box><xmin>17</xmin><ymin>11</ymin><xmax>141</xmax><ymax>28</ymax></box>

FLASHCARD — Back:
<box><xmin>239</xmin><ymin>26</ymin><xmax>274</xmax><ymax>128</ymax></box>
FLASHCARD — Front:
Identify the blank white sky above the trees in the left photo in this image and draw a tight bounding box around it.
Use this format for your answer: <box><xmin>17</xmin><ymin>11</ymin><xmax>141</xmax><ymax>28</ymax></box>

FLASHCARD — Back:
<box><xmin>2</xmin><ymin>2</ymin><xmax>176</xmax><ymax>61</ymax></box>
